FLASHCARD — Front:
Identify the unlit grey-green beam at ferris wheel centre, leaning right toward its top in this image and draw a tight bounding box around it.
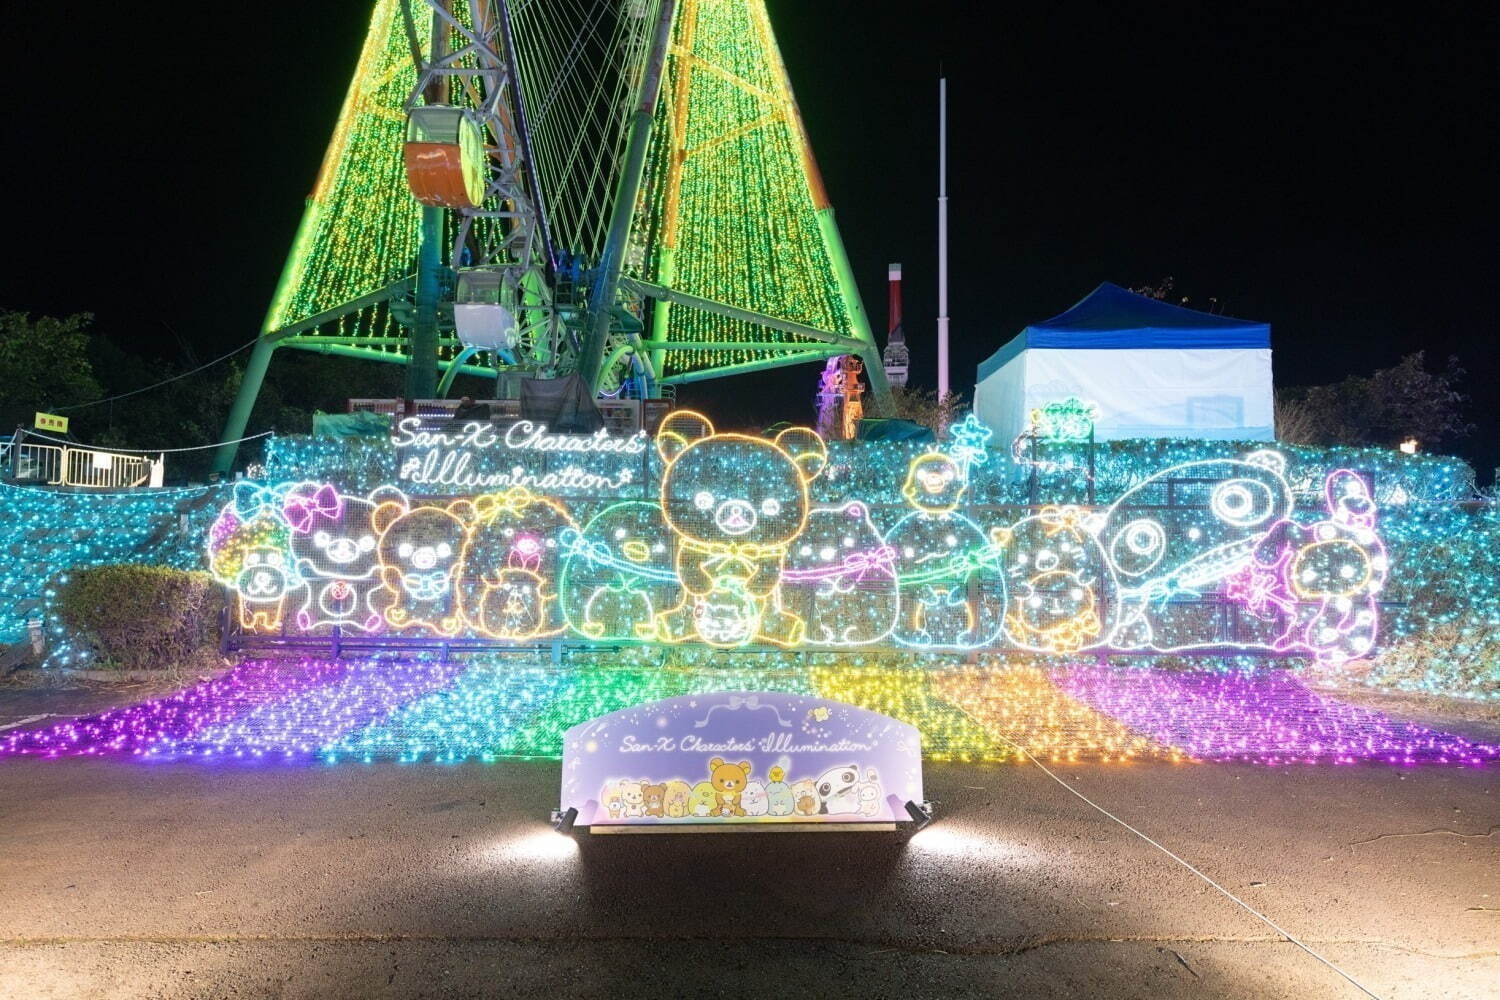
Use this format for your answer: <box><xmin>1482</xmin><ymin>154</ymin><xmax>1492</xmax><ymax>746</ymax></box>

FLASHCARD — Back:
<box><xmin>578</xmin><ymin>0</ymin><xmax>677</xmax><ymax>394</ymax></box>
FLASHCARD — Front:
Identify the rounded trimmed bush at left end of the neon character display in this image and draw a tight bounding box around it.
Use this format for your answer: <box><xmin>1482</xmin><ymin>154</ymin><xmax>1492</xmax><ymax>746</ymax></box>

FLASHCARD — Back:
<box><xmin>56</xmin><ymin>565</ymin><xmax>224</xmax><ymax>670</ymax></box>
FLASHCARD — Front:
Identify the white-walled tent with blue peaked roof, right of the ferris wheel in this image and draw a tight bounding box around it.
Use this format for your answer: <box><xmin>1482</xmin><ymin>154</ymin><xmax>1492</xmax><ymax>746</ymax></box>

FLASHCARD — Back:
<box><xmin>974</xmin><ymin>282</ymin><xmax>1275</xmax><ymax>442</ymax></box>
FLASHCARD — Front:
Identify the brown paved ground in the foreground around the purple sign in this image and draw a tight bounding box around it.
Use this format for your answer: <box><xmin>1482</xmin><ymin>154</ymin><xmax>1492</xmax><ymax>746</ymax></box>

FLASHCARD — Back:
<box><xmin>0</xmin><ymin>702</ymin><xmax>1500</xmax><ymax>1000</ymax></box>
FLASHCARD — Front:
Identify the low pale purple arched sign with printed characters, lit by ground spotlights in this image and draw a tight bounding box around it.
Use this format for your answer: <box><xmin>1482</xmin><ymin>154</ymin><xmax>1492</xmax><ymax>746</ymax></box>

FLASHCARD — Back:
<box><xmin>563</xmin><ymin>691</ymin><xmax>923</xmax><ymax>834</ymax></box>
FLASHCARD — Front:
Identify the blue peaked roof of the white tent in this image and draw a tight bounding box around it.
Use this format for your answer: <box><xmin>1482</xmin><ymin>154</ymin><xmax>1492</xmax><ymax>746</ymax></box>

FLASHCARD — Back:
<box><xmin>980</xmin><ymin>282</ymin><xmax>1271</xmax><ymax>382</ymax></box>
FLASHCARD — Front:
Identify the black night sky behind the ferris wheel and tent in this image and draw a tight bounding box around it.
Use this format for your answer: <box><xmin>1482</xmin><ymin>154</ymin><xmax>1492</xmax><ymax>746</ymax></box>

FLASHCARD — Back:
<box><xmin>0</xmin><ymin>0</ymin><xmax>1500</xmax><ymax>475</ymax></box>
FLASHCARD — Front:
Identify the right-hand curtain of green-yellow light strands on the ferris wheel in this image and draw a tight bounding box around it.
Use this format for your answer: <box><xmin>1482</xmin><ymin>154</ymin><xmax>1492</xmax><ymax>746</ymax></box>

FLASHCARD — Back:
<box><xmin>651</xmin><ymin>0</ymin><xmax>852</xmax><ymax>372</ymax></box>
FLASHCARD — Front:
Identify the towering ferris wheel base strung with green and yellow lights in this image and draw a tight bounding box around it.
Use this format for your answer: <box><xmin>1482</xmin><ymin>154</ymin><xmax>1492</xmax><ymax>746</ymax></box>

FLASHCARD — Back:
<box><xmin>219</xmin><ymin>0</ymin><xmax>888</xmax><ymax>469</ymax></box>
